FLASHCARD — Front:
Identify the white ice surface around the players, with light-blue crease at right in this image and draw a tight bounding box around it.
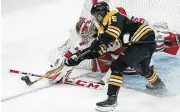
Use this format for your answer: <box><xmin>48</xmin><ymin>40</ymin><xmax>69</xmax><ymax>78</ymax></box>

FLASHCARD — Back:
<box><xmin>1</xmin><ymin>0</ymin><xmax>180</xmax><ymax>112</ymax></box>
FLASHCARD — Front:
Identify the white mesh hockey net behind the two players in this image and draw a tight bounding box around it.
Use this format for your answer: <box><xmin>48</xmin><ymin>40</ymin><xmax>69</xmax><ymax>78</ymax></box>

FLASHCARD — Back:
<box><xmin>49</xmin><ymin>0</ymin><xmax>180</xmax><ymax>70</ymax></box>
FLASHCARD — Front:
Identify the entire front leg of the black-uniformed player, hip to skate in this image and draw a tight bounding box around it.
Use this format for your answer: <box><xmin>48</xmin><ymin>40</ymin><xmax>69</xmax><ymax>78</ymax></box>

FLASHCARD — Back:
<box><xmin>96</xmin><ymin>43</ymin><xmax>159</xmax><ymax>110</ymax></box>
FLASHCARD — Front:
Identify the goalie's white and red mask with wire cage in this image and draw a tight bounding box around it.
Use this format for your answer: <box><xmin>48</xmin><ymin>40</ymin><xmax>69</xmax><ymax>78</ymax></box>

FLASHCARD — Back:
<box><xmin>76</xmin><ymin>17</ymin><xmax>97</xmax><ymax>43</ymax></box>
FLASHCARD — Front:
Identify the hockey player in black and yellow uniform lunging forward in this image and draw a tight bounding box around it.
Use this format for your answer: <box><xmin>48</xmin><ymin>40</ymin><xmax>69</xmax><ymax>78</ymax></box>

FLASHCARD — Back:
<box><xmin>65</xmin><ymin>2</ymin><xmax>165</xmax><ymax>111</ymax></box>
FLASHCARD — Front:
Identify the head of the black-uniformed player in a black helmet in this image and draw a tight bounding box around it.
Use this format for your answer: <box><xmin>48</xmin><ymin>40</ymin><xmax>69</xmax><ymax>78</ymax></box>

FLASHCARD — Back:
<box><xmin>91</xmin><ymin>1</ymin><xmax>109</xmax><ymax>24</ymax></box>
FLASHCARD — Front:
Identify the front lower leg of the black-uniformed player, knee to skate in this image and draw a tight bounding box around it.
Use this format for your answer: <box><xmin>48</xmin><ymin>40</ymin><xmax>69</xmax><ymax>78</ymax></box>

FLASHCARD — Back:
<box><xmin>96</xmin><ymin>58</ymin><xmax>127</xmax><ymax>111</ymax></box>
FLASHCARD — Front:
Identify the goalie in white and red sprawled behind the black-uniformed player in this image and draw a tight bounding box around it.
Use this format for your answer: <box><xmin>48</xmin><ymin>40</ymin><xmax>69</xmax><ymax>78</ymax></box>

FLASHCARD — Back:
<box><xmin>47</xmin><ymin>7</ymin><xmax>180</xmax><ymax>84</ymax></box>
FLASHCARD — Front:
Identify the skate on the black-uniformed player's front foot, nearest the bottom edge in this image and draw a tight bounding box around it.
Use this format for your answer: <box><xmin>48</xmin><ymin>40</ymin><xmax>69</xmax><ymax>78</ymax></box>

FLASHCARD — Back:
<box><xmin>96</xmin><ymin>96</ymin><xmax>117</xmax><ymax>112</ymax></box>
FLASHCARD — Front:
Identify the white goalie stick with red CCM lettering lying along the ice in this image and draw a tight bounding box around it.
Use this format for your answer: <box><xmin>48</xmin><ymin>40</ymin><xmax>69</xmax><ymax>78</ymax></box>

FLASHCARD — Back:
<box><xmin>9</xmin><ymin>69</ymin><xmax>104</xmax><ymax>89</ymax></box>
